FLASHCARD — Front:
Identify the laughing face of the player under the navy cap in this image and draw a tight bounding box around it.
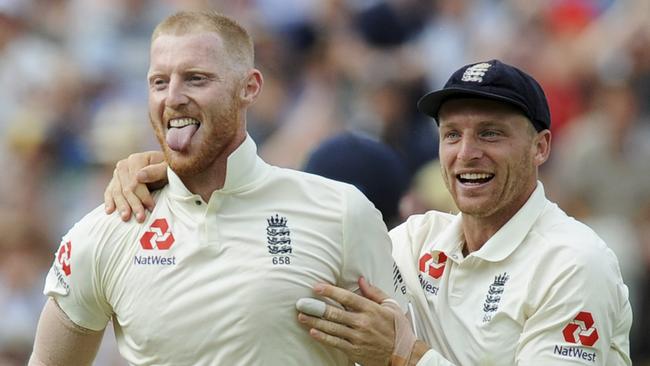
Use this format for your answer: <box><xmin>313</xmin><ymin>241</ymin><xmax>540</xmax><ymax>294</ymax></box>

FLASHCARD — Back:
<box><xmin>439</xmin><ymin>99</ymin><xmax>550</xmax><ymax>223</ymax></box>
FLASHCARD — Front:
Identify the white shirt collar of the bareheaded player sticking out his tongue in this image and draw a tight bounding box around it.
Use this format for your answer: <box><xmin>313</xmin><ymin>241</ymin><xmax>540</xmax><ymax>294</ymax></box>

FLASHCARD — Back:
<box><xmin>167</xmin><ymin>135</ymin><xmax>270</xmax><ymax>200</ymax></box>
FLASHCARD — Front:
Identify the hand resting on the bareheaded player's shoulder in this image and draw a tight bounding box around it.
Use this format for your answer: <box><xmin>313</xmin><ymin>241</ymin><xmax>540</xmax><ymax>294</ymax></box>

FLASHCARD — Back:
<box><xmin>104</xmin><ymin>151</ymin><xmax>167</xmax><ymax>223</ymax></box>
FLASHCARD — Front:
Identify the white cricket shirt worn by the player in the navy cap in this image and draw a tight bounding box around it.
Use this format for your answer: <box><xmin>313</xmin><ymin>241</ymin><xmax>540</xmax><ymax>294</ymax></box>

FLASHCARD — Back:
<box><xmin>391</xmin><ymin>182</ymin><xmax>632</xmax><ymax>366</ymax></box>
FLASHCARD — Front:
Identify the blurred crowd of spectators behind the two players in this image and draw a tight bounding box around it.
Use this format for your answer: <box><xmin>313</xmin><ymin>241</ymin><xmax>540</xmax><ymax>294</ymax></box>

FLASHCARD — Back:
<box><xmin>0</xmin><ymin>0</ymin><xmax>650</xmax><ymax>365</ymax></box>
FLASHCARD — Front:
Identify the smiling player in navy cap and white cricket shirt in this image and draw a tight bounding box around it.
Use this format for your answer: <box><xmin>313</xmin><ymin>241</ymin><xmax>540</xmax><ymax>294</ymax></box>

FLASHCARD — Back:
<box><xmin>98</xmin><ymin>60</ymin><xmax>632</xmax><ymax>366</ymax></box>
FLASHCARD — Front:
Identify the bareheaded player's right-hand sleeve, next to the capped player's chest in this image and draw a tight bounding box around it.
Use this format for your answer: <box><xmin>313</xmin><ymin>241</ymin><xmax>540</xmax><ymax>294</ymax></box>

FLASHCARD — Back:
<box><xmin>339</xmin><ymin>185</ymin><xmax>407</xmax><ymax>312</ymax></box>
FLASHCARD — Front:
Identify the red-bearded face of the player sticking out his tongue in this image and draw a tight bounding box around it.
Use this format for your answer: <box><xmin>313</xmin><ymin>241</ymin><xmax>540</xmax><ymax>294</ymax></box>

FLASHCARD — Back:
<box><xmin>148</xmin><ymin>32</ymin><xmax>247</xmax><ymax>176</ymax></box>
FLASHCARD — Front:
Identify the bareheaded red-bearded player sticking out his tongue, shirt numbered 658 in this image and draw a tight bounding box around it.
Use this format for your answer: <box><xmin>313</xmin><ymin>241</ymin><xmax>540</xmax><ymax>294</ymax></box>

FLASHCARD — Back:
<box><xmin>30</xmin><ymin>12</ymin><xmax>405</xmax><ymax>365</ymax></box>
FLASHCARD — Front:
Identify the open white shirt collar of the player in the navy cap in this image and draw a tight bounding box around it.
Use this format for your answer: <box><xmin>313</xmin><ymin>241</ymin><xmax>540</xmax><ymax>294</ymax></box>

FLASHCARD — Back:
<box><xmin>433</xmin><ymin>181</ymin><xmax>547</xmax><ymax>262</ymax></box>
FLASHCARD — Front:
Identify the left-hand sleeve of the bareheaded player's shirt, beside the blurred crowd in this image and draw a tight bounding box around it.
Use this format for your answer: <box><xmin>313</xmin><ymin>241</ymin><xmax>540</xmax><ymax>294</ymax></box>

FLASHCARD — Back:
<box><xmin>43</xmin><ymin>208</ymin><xmax>112</xmax><ymax>330</ymax></box>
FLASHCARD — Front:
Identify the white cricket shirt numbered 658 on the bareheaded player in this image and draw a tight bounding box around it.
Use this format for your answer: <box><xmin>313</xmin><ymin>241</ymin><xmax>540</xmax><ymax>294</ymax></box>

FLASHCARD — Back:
<box><xmin>44</xmin><ymin>137</ymin><xmax>405</xmax><ymax>365</ymax></box>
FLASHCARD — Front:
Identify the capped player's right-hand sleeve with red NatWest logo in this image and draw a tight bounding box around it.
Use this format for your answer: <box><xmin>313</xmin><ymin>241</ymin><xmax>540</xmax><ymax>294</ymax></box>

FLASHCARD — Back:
<box><xmin>516</xmin><ymin>242</ymin><xmax>632</xmax><ymax>366</ymax></box>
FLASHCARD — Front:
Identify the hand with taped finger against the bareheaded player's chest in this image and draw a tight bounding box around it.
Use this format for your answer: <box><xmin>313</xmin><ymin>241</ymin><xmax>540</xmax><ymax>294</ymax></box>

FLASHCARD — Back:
<box><xmin>298</xmin><ymin>277</ymin><xmax>396</xmax><ymax>366</ymax></box>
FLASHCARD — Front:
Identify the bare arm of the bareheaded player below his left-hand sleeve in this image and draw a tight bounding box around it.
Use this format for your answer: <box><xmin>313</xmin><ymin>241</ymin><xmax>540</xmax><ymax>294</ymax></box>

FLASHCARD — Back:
<box><xmin>29</xmin><ymin>298</ymin><xmax>104</xmax><ymax>366</ymax></box>
